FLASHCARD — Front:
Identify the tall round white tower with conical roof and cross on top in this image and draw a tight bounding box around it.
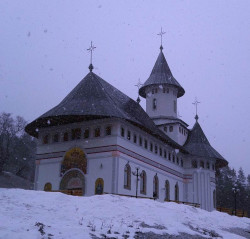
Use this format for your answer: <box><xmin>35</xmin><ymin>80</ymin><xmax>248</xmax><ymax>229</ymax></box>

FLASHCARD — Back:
<box><xmin>139</xmin><ymin>30</ymin><xmax>188</xmax><ymax>145</ymax></box>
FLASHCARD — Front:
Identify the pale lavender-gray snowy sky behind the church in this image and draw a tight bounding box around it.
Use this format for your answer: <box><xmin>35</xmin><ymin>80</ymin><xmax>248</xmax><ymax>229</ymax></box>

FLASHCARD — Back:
<box><xmin>0</xmin><ymin>0</ymin><xmax>250</xmax><ymax>174</ymax></box>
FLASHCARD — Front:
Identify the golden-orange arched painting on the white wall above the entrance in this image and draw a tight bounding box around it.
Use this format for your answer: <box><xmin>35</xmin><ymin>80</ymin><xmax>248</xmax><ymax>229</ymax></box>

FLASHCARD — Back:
<box><xmin>61</xmin><ymin>148</ymin><xmax>87</xmax><ymax>175</ymax></box>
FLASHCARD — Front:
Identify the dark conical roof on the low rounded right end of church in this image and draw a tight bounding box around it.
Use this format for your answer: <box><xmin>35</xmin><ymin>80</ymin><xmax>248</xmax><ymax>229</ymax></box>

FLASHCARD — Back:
<box><xmin>183</xmin><ymin>121</ymin><xmax>228</xmax><ymax>167</ymax></box>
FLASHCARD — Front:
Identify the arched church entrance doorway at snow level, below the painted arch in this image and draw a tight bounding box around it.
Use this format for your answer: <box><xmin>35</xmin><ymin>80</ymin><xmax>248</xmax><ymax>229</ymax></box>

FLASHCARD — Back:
<box><xmin>60</xmin><ymin>170</ymin><xmax>85</xmax><ymax>196</ymax></box>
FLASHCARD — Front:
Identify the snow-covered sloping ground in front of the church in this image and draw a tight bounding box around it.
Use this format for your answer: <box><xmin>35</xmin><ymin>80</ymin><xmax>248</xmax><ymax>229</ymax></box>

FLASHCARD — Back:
<box><xmin>0</xmin><ymin>188</ymin><xmax>250</xmax><ymax>239</ymax></box>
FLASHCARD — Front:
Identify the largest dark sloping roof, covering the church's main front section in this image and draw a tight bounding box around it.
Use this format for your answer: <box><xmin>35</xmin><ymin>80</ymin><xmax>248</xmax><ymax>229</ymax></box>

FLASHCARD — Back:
<box><xmin>25</xmin><ymin>72</ymin><xmax>183</xmax><ymax>149</ymax></box>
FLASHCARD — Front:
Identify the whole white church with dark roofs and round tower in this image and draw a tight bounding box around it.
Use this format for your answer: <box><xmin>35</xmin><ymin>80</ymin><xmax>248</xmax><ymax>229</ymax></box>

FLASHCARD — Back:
<box><xmin>25</xmin><ymin>37</ymin><xmax>228</xmax><ymax>211</ymax></box>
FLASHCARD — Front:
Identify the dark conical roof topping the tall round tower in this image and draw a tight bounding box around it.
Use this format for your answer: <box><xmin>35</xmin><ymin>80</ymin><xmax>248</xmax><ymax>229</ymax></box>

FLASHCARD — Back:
<box><xmin>139</xmin><ymin>48</ymin><xmax>185</xmax><ymax>98</ymax></box>
